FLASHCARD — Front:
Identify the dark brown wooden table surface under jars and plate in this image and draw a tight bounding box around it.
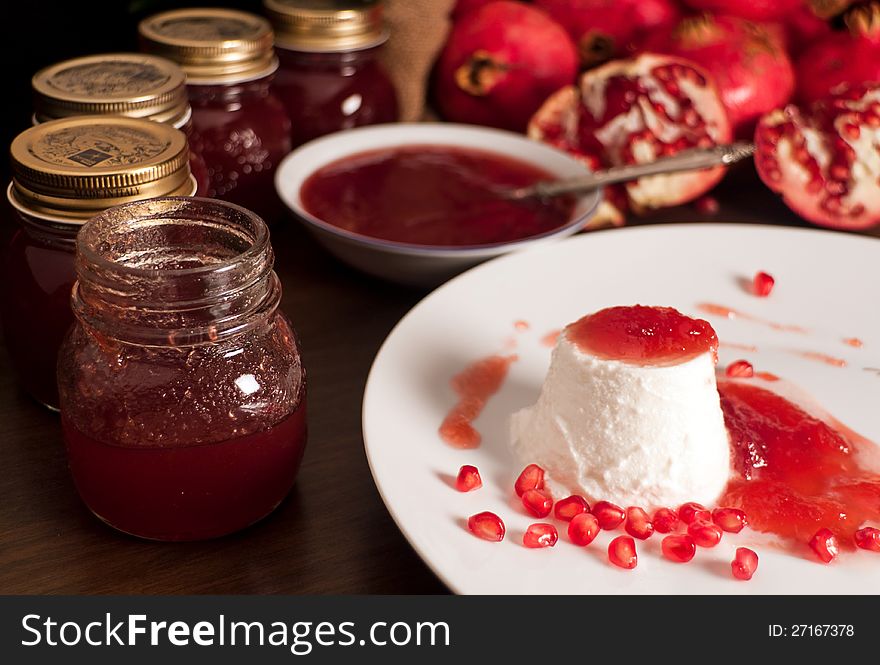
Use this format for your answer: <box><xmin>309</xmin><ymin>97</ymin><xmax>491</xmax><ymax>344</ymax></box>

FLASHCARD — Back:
<box><xmin>0</xmin><ymin>167</ymin><xmax>880</xmax><ymax>594</ymax></box>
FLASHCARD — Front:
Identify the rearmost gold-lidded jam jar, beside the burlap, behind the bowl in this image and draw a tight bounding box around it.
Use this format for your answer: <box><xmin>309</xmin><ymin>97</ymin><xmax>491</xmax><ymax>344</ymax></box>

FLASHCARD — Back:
<box><xmin>264</xmin><ymin>0</ymin><xmax>399</xmax><ymax>147</ymax></box>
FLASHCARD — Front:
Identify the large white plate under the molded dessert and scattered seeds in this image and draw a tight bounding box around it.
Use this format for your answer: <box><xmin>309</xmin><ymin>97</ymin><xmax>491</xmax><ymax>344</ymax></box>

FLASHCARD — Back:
<box><xmin>363</xmin><ymin>224</ymin><xmax>880</xmax><ymax>594</ymax></box>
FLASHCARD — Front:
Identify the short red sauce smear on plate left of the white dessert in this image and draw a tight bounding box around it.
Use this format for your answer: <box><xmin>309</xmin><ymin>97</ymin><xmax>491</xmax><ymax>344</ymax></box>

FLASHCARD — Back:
<box><xmin>440</xmin><ymin>355</ymin><xmax>517</xmax><ymax>448</ymax></box>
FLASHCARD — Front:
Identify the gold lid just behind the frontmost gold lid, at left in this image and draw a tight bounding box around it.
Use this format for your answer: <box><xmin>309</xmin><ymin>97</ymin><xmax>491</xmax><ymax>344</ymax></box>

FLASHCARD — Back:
<box><xmin>31</xmin><ymin>53</ymin><xmax>190</xmax><ymax>127</ymax></box>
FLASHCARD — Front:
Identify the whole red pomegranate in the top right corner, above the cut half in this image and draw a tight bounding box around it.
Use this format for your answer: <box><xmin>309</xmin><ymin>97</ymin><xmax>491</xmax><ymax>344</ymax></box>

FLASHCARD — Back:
<box><xmin>797</xmin><ymin>2</ymin><xmax>880</xmax><ymax>102</ymax></box>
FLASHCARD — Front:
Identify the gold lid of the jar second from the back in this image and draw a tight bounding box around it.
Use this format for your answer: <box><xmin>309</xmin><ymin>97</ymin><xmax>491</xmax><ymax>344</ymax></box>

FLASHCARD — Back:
<box><xmin>138</xmin><ymin>8</ymin><xmax>278</xmax><ymax>84</ymax></box>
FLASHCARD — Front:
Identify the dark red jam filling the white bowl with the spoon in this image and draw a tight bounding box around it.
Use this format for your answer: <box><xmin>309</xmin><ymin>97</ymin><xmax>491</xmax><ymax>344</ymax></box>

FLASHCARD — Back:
<box><xmin>301</xmin><ymin>145</ymin><xmax>573</xmax><ymax>247</ymax></box>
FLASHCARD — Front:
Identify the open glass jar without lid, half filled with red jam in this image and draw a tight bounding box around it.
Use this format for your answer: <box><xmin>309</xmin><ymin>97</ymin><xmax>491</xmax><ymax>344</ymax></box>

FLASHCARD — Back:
<box><xmin>58</xmin><ymin>198</ymin><xmax>306</xmax><ymax>540</ymax></box>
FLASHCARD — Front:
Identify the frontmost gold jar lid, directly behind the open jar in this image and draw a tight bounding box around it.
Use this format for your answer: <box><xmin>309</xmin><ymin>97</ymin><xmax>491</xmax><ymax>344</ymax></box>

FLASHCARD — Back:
<box><xmin>9</xmin><ymin>116</ymin><xmax>194</xmax><ymax>224</ymax></box>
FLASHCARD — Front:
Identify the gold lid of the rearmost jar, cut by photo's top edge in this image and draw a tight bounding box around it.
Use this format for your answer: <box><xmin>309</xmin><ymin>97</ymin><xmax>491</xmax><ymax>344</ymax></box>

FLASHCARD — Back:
<box><xmin>263</xmin><ymin>0</ymin><xmax>388</xmax><ymax>52</ymax></box>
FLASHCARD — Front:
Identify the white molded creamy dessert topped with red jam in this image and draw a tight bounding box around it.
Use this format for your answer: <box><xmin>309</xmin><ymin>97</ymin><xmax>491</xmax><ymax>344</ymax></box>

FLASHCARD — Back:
<box><xmin>511</xmin><ymin>305</ymin><xmax>730</xmax><ymax>508</ymax></box>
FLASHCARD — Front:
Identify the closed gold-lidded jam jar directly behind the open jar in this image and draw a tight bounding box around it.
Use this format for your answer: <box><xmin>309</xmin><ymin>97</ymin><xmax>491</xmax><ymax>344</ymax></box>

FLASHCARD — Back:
<box><xmin>0</xmin><ymin>116</ymin><xmax>196</xmax><ymax>409</ymax></box>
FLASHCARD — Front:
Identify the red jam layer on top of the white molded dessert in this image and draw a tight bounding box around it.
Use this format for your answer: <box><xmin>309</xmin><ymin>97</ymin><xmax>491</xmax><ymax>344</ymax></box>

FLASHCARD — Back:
<box><xmin>565</xmin><ymin>305</ymin><xmax>718</xmax><ymax>365</ymax></box>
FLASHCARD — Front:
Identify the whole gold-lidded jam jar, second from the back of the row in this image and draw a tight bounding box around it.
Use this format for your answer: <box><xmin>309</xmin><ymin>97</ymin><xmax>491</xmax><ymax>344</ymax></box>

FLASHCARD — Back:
<box><xmin>139</xmin><ymin>9</ymin><xmax>290</xmax><ymax>216</ymax></box>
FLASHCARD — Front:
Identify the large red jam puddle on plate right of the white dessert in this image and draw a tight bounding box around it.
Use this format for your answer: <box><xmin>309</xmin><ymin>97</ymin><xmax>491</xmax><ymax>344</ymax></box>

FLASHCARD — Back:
<box><xmin>718</xmin><ymin>381</ymin><xmax>880</xmax><ymax>548</ymax></box>
